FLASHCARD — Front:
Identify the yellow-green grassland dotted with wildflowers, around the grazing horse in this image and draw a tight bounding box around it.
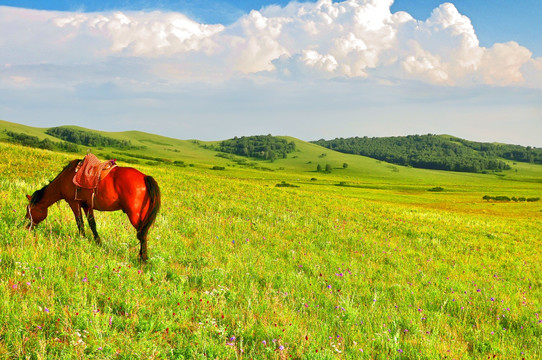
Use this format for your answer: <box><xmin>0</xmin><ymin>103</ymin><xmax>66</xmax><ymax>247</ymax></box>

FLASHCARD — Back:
<box><xmin>0</xmin><ymin>130</ymin><xmax>542</xmax><ymax>359</ymax></box>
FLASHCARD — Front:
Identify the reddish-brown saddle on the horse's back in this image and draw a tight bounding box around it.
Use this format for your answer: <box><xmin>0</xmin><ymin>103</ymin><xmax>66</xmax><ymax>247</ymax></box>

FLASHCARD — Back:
<box><xmin>73</xmin><ymin>153</ymin><xmax>117</xmax><ymax>200</ymax></box>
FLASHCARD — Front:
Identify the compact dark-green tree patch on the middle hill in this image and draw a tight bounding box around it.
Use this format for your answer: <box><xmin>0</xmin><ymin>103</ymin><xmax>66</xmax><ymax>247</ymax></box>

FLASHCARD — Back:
<box><xmin>216</xmin><ymin>135</ymin><xmax>295</xmax><ymax>161</ymax></box>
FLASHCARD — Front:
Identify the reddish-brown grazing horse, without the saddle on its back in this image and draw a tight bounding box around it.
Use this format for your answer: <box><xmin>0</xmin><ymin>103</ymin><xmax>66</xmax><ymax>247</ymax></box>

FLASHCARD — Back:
<box><xmin>26</xmin><ymin>160</ymin><xmax>161</xmax><ymax>261</ymax></box>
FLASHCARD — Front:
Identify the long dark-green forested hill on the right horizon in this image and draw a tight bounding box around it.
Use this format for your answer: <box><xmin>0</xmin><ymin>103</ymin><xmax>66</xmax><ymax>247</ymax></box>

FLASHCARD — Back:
<box><xmin>313</xmin><ymin>134</ymin><xmax>542</xmax><ymax>172</ymax></box>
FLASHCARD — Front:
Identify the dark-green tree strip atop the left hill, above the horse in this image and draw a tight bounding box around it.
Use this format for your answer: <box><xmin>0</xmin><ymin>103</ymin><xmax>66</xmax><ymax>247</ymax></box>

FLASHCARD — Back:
<box><xmin>45</xmin><ymin>127</ymin><xmax>132</xmax><ymax>149</ymax></box>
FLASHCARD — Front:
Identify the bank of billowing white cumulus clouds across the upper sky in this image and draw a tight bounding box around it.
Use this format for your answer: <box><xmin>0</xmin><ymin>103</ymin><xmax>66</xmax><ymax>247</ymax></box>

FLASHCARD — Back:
<box><xmin>0</xmin><ymin>0</ymin><xmax>542</xmax><ymax>87</ymax></box>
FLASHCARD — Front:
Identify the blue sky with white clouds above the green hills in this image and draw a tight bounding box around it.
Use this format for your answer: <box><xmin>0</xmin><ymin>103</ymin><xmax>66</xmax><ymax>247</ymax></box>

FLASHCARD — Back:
<box><xmin>0</xmin><ymin>0</ymin><xmax>542</xmax><ymax>147</ymax></box>
